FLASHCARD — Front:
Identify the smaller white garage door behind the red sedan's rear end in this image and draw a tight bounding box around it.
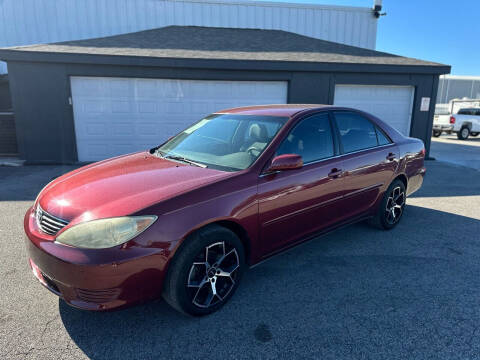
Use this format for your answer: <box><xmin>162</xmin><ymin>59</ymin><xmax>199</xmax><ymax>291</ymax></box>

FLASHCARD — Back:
<box><xmin>334</xmin><ymin>85</ymin><xmax>414</xmax><ymax>136</ymax></box>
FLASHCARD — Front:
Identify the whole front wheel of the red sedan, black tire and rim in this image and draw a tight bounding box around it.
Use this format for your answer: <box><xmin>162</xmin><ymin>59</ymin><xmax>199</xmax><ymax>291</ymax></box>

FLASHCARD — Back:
<box><xmin>163</xmin><ymin>225</ymin><xmax>245</xmax><ymax>316</ymax></box>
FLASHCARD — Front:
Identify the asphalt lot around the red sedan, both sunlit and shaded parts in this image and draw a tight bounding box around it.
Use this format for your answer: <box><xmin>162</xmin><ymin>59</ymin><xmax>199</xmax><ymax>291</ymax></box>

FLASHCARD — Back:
<box><xmin>0</xmin><ymin>146</ymin><xmax>480</xmax><ymax>359</ymax></box>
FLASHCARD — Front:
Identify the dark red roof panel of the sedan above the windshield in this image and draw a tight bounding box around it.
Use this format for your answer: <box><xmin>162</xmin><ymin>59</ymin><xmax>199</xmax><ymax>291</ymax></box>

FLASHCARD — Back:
<box><xmin>215</xmin><ymin>104</ymin><xmax>333</xmax><ymax>117</ymax></box>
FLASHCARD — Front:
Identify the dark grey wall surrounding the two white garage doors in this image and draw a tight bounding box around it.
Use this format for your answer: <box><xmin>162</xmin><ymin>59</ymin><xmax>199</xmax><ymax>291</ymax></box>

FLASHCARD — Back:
<box><xmin>9</xmin><ymin>61</ymin><xmax>438</xmax><ymax>163</ymax></box>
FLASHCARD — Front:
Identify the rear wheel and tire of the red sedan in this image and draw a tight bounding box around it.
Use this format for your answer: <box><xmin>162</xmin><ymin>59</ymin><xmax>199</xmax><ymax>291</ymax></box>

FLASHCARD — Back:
<box><xmin>370</xmin><ymin>179</ymin><xmax>406</xmax><ymax>230</ymax></box>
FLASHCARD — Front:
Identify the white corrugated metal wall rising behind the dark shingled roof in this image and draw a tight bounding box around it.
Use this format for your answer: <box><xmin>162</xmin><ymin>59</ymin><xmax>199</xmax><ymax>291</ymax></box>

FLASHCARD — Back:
<box><xmin>0</xmin><ymin>0</ymin><xmax>377</xmax><ymax>74</ymax></box>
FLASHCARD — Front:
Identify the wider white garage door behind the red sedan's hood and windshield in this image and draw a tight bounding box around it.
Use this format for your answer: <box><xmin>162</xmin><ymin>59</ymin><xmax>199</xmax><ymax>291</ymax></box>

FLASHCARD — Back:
<box><xmin>71</xmin><ymin>77</ymin><xmax>287</xmax><ymax>161</ymax></box>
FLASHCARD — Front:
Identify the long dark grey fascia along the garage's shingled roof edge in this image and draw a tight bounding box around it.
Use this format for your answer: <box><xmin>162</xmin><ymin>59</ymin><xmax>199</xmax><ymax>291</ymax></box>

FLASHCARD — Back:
<box><xmin>0</xmin><ymin>49</ymin><xmax>451</xmax><ymax>75</ymax></box>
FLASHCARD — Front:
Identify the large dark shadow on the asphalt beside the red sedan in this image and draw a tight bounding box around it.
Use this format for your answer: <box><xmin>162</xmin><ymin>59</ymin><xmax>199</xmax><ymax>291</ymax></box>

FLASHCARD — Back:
<box><xmin>59</xmin><ymin>206</ymin><xmax>480</xmax><ymax>359</ymax></box>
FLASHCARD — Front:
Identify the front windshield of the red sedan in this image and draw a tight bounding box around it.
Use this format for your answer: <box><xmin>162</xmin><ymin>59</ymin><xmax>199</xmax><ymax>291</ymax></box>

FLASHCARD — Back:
<box><xmin>157</xmin><ymin>114</ymin><xmax>288</xmax><ymax>171</ymax></box>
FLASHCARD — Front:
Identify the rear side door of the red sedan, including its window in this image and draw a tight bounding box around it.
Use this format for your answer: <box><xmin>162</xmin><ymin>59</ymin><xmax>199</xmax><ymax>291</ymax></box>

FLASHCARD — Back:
<box><xmin>333</xmin><ymin>111</ymin><xmax>399</xmax><ymax>220</ymax></box>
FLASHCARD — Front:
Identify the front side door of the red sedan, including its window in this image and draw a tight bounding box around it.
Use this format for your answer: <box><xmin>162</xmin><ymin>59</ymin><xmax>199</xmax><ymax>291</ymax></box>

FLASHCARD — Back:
<box><xmin>258</xmin><ymin>112</ymin><xmax>342</xmax><ymax>254</ymax></box>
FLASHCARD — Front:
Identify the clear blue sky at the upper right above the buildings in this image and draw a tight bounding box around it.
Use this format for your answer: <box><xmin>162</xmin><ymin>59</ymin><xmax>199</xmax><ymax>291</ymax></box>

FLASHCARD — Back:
<box><xmin>256</xmin><ymin>0</ymin><xmax>474</xmax><ymax>76</ymax></box>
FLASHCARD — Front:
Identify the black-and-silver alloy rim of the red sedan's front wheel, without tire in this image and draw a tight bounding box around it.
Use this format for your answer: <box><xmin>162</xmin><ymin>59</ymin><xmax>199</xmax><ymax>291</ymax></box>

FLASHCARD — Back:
<box><xmin>187</xmin><ymin>241</ymin><xmax>240</xmax><ymax>308</ymax></box>
